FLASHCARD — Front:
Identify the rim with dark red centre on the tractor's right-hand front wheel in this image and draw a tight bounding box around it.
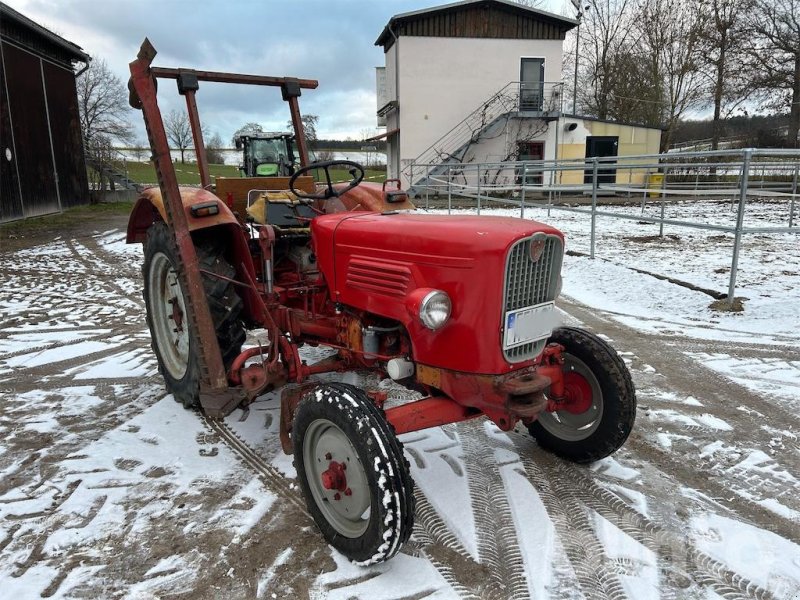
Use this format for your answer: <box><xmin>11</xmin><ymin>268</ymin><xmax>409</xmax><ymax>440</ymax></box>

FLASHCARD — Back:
<box><xmin>539</xmin><ymin>352</ymin><xmax>603</xmax><ymax>442</ymax></box>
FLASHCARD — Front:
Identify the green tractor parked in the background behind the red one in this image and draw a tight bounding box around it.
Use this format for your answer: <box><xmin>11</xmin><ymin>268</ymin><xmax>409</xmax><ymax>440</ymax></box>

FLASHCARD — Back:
<box><xmin>236</xmin><ymin>132</ymin><xmax>299</xmax><ymax>177</ymax></box>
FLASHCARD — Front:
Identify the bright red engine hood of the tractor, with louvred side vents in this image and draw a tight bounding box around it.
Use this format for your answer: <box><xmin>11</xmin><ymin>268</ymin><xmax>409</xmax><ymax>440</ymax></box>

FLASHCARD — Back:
<box><xmin>312</xmin><ymin>213</ymin><xmax>563</xmax><ymax>373</ymax></box>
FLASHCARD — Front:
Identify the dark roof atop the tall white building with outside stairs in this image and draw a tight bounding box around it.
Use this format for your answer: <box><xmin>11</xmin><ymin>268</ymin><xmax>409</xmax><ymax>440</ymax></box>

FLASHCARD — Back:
<box><xmin>375</xmin><ymin>0</ymin><xmax>578</xmax><ymax>50</ymax></box>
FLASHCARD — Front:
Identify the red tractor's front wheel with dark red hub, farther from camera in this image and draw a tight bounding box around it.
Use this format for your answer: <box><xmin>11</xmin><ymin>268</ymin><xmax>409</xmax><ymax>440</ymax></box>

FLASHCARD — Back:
<box><xmin>528</xmin><ymin>327</ymin><xmax>636</xmax><ymax>463</ymax></box>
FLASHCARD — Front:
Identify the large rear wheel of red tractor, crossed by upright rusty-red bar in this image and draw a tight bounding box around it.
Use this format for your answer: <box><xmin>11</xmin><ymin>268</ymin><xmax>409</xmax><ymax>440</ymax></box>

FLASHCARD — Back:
<box><xmin>142</xmin><ymin>222</ymin><xmax>246</xmax><ymax>408</ymax></box>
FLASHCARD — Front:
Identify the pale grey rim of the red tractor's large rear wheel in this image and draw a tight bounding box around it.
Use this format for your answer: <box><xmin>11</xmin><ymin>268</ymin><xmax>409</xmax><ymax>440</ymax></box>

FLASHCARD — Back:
<box><xmin>148</xmin><ymin>252</ymin><xmax>189</xmax><ymax>379</ymax></box>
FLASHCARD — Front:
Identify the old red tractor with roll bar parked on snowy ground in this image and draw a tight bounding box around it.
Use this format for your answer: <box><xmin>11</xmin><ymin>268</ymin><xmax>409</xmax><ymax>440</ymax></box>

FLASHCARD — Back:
<box><xmin>128</xmin><ymin>40</ymin><xmax>636</xmax><ymax>564</ymax></box>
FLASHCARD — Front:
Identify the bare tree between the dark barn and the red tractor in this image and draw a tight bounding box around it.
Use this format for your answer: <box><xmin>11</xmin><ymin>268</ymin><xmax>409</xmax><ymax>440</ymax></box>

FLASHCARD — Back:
<box><xmin>76</xmin><ymin>59</ymin><xmax>133</xmax><ymax>145</ymax></box>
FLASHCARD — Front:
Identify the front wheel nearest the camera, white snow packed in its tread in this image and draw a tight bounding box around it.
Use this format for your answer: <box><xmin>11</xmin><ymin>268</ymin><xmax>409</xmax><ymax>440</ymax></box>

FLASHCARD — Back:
<box><xmin>292</xmin><ymin>384</ymin><xmax>415</xmax><ymax>565</ymax></box>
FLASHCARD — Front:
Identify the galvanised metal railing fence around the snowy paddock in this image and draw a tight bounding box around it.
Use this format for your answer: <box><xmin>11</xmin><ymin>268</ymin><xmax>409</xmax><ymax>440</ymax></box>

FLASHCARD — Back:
<box><xmin>414</xmin><ymin>148</ymin><xmax>800</xmax><ymax>304</ymax></box>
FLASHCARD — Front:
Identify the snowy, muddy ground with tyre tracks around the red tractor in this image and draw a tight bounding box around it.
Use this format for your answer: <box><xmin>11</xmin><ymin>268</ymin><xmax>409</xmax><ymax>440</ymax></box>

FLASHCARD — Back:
<box><xmin>0</xmin><ymin>207</ymin><xmax>800</xmax><ymax>600</ymax></box>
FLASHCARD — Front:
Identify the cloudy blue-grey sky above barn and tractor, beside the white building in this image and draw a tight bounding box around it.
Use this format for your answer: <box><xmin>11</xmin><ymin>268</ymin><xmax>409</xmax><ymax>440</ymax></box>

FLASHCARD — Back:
<box><xmin>3</xmin><ymin>0</ymin><xmax>569</xmax><ymax>141</ymax></box>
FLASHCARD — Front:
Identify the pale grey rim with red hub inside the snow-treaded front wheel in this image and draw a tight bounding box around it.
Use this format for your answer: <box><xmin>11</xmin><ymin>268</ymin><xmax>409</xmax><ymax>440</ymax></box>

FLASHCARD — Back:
<box><xmin>303</xmin><ymin>419</ymin><xmax>372</xmax><ymax>538</ymax></box>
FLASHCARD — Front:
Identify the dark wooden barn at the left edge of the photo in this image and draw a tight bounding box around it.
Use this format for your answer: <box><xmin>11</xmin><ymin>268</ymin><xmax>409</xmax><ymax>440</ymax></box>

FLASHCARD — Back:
<box><xmin>0</xmin><ymin>2</ymin><xmax>90</xmax><ymax>222</ymax></box>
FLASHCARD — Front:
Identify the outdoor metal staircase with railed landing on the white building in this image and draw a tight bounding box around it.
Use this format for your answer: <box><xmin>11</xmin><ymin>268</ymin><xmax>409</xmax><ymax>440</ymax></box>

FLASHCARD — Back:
<box><xmin>403</xmin><ymin>81</ymin><xmax>563</xmax><ymax>193</ymax></box>
